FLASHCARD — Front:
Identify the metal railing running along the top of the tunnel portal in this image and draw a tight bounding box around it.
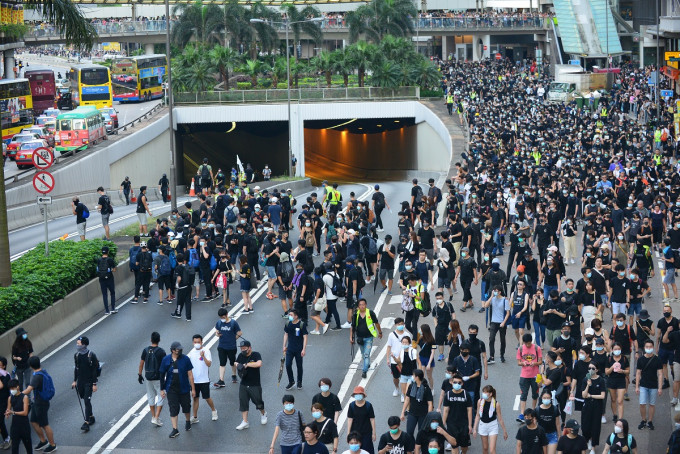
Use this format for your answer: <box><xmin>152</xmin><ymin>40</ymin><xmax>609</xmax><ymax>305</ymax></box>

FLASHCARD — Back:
<box><xmin>173</xmin><ymin>87</ymin><xmax>420</xmax><ymax>105</ymax></box>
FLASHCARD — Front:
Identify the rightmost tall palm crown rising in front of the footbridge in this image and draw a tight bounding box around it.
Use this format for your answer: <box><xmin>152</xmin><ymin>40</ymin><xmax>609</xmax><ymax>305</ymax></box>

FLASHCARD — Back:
<box><xmin>345</xmin><ymin>0</ymin><xmax>418</xmax><ymax>43</ymax></box>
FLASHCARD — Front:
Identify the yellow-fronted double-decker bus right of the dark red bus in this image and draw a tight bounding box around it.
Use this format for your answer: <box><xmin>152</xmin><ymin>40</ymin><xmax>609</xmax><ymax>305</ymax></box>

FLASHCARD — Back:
<box><xmin>68</xmin><ymin>65</ymin><xmax>113</xmax><ymax>109</ymax></box>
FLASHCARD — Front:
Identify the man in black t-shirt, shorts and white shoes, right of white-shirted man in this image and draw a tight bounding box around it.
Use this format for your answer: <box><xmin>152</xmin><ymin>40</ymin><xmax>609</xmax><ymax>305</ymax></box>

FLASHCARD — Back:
<box><xmin>236</xmin><ymin>340</ymin><xmax>267</xmax><ymax>430</ymax></box>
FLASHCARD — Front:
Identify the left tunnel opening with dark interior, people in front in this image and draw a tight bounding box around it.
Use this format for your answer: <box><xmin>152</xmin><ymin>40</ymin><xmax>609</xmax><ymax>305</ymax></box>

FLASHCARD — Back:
<box><xmin>176</xmin><ymin>121</ymin><xmax>288</xmax><ymax>185</ymax></box>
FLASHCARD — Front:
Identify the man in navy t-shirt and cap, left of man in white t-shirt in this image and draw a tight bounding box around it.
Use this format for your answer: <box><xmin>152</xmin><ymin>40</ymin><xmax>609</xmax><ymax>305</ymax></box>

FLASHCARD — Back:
<box><xmin>159</xmin><ymin>341</ymin><xmax>196</xmax><ymax>438</ymax></box>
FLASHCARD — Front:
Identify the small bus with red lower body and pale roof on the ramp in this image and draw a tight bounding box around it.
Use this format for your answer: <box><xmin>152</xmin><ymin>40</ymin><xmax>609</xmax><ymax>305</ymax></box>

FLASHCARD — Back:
<box><xmin>54</xmin><ymin>106</ymin><xmax>108</xmax><ymax>152</ymax></box>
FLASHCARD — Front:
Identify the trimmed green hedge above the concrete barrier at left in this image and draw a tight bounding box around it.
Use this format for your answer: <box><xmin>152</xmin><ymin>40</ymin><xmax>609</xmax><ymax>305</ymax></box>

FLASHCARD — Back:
<box><xmin>0</xmin><ymin>240</ymin><xmax>117</xmax><ymax>333</ymax></box>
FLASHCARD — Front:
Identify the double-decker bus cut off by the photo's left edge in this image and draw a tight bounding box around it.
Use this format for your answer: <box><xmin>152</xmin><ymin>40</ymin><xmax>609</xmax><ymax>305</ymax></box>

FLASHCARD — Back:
<box><xmin>0</xmin><ymin>79</ymin><xmax>33</xmax><ymax>143</ymax></box>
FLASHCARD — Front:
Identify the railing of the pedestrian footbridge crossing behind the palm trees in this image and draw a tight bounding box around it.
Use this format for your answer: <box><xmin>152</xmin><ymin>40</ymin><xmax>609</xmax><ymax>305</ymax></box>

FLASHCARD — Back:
<box><xmin>24</xmin><ymin>16</ymin><xmax>549</xmax><ymax>40</ymax></box>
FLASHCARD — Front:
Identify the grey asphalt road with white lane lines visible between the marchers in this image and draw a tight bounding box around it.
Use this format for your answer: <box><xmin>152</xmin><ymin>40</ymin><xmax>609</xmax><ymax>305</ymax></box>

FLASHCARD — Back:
<box><xmin>10</xmin><ymin>182</ymin><xmax>672</xmax><ymax>454</ymax></box>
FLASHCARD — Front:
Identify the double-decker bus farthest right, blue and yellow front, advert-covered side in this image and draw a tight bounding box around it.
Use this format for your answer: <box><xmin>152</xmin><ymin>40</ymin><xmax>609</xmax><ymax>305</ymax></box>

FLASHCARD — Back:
<box><xmin>111</xmin><ymin>54</ymin><xmax>168</xmax><ymax>102</ymax></box>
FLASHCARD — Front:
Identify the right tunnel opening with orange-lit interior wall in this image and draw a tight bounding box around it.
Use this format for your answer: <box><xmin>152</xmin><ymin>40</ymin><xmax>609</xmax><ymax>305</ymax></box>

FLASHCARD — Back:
<box><xmin>304</xmin><ymin>118</ymin><xmax>418</xmax><ymax>182</ymax></box>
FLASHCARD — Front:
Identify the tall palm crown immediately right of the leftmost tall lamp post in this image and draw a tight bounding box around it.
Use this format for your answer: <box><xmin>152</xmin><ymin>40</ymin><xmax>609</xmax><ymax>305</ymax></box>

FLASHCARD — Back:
<box><xmin>172</xmin><ymin>1</ymin><xmax>223</xmax><ymax>47</ymax></box>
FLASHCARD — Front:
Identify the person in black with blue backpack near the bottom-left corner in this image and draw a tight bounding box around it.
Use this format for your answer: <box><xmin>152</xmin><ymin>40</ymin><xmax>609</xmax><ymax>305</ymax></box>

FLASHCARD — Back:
<box><xmin>23</xmin><ymin>356</ymin><xmax>57</xmax><ymax>453</ymax></box>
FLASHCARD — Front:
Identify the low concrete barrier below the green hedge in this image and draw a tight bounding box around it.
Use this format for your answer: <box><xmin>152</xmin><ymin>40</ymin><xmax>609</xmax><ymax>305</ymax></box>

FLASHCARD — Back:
<box><xmin>0</xmin><ymin>260</ymin><xmax>135</xmax><ymax>367</ymax></box>
